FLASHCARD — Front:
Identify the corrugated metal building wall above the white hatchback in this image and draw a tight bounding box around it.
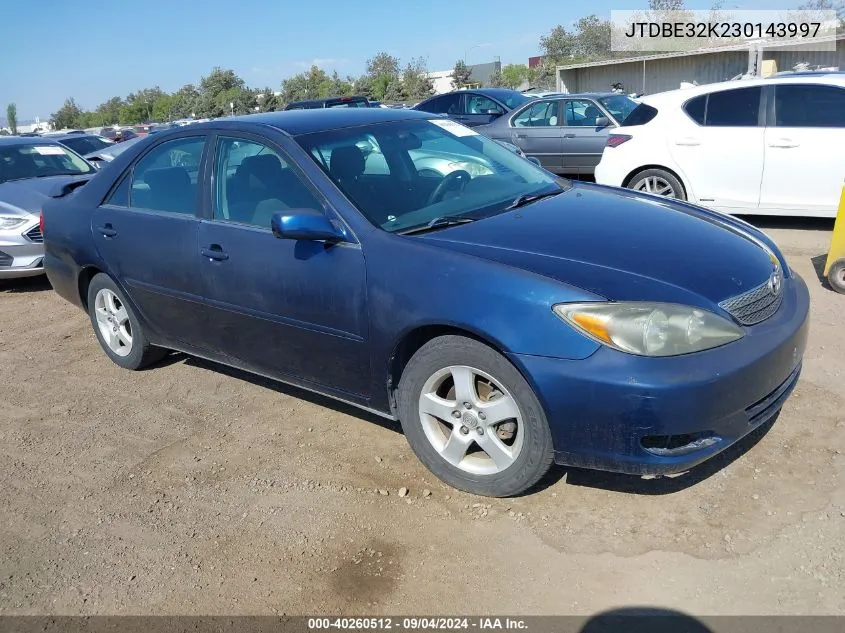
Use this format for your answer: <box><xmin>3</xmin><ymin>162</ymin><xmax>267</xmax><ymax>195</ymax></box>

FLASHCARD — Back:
<box><xmin>558</xmin><ymin>41</ymin><xmax>845</xmax><ymax>94</ymax></box>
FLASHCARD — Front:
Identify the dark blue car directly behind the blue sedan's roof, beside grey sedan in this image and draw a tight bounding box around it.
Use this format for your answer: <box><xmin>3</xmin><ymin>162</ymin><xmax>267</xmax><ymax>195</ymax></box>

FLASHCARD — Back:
<box><xmin>413</xmin><ymin>88</ymin><xmax>536</xmax><ymax>127</ymax></box>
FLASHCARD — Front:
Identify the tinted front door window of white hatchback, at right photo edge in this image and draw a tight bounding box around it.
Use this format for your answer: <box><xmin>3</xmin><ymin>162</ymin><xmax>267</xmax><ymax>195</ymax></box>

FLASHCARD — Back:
<box><xmin>775</xmin><ymin>84</ymin><xmax>845</xmax><ymax>127</ymax></box>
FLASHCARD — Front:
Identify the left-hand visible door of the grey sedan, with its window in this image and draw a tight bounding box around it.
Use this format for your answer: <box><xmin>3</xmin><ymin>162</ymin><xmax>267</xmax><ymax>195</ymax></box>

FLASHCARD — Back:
<box><xmin>510</xmin><ymin>99</ymin><xmax>563</xmax><ymax>173</ymax></box>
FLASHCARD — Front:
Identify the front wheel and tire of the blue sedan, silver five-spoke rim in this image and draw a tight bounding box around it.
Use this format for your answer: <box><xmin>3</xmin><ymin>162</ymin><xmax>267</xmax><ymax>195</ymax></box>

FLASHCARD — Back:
<box><xmin>398</xmin><ymin>336</ymin><xmax>554</xmax><ymax>497</ymax></box>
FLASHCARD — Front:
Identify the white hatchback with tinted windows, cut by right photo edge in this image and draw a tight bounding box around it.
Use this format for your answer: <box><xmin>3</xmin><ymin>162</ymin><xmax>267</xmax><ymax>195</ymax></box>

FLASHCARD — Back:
<box><xmin>595</xmin><ymin>73</ymin><xmax>845</xmax><ymax>217</ymax></box>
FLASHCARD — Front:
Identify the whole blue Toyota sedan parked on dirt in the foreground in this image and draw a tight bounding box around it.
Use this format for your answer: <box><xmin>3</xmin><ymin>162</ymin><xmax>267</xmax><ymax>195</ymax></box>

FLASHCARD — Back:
<box><xmin>42</xmin><ymin>108</ymin><xmax>809</xmax><ymax>496</ymax></box>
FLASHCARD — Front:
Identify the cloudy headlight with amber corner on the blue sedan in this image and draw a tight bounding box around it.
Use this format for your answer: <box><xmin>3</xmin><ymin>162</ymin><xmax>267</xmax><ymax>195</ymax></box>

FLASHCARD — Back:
<box><xmin>553</xmin><ymin>301</ymin><xmax>743</xmax><ymax>356</ymax></box>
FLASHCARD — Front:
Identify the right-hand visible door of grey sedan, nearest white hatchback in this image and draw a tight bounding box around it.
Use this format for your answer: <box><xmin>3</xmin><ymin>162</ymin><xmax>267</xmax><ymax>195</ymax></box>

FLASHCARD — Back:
<box><xmin>561</xmin><ymin>99</ymin><xmax>608</xmax><ymax>174</ymax></box>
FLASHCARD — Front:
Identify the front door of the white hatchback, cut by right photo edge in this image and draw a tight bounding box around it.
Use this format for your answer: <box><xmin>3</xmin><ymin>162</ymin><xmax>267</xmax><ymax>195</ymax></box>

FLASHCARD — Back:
<box><xmin>760</xmin><ymin>83</ymin><xmax>845</xmax><ymax>217</ymax></box>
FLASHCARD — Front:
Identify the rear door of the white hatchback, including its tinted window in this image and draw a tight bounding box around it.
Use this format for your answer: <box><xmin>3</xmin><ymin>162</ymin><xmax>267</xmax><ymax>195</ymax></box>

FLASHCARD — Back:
<box><xmin>667</xmin><ymin>86</ymin><xmax>765</xmax><ymax>213</ymax></box>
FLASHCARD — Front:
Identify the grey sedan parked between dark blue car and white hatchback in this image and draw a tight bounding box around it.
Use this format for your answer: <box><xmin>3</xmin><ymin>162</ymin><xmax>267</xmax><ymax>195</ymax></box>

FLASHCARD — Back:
<box><xmin>476</xmin><ymin>92</ymin><xmax>637</xmax><ymax>174</ymax></box>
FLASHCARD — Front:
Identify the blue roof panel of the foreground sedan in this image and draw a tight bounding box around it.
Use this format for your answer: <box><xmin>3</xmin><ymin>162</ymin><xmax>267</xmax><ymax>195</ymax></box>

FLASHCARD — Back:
<box><xmin>191</xmin><ymin>108</ymin><xmax>436</xmax><ymax>136</ymax></box>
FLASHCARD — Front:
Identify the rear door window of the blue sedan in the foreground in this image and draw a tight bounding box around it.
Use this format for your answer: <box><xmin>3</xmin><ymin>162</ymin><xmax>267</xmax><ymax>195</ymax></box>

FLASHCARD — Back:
<box><xmin>129</xmin><ymin>136</ymin><xmax>205</xmax><ymax>215</ymax></box>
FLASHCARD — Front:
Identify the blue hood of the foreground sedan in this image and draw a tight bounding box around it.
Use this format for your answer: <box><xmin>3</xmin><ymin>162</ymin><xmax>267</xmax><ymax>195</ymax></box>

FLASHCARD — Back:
<box><xmin>420</xmin><ymin>183</ymin><xmax>775</xmax><ymax>309</ymax></box>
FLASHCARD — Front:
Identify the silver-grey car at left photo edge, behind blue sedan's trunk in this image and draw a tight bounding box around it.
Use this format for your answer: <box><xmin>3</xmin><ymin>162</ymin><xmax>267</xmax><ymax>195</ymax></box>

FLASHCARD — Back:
<box><xmin>0</xmin><ymin>136</ymin><xmax>94</xmax><ymax>279</ymax></box>
